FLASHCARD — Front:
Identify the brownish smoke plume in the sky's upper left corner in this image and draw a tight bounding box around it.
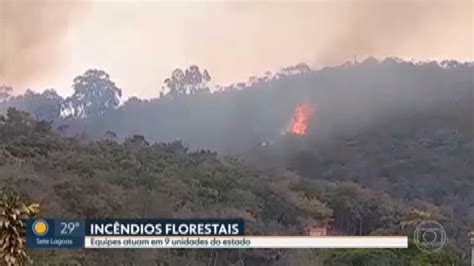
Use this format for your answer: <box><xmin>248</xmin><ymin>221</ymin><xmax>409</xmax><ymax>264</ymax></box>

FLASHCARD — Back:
<box><xmin>0</xmin><ymin>0</ymin><xmax>87</xmax><ymax>91</ymax></box>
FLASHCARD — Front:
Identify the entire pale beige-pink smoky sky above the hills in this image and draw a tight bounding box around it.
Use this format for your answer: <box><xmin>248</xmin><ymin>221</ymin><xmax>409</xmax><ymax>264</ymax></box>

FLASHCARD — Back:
<box><xmin>0</xmin><ymin>0</ymin><xmax>474</xmax><ymax>98</ymax></box>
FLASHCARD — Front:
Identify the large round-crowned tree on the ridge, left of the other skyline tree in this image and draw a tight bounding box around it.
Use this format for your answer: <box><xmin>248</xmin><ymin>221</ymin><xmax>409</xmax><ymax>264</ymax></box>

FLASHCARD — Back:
<box><xmin>63</xmin><ymin>69</ymin><xmax>122</xmax><ymax>118</ymax></box>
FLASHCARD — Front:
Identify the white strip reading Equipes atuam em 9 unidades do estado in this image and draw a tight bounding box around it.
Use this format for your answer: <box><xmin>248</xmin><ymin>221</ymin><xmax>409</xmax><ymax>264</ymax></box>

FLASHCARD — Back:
<box><xmin>84</xmin><ymin>236</ymin><xmax>408</xmax><ymax>248</ymax></box>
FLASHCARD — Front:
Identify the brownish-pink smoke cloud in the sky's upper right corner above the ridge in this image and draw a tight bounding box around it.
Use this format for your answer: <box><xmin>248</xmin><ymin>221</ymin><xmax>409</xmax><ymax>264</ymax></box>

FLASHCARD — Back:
<box><xmin>316</xmin><ymin>1</ymin><xmax>473</xmax><ymax>66</ymax></box>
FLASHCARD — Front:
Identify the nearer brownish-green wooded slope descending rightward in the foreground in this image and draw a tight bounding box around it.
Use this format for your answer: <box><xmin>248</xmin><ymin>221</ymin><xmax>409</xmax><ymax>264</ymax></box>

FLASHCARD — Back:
<box><xmin>0</xmin><ymin>109</ymin><xmax>460</xmax><ymax>265</ymax></box>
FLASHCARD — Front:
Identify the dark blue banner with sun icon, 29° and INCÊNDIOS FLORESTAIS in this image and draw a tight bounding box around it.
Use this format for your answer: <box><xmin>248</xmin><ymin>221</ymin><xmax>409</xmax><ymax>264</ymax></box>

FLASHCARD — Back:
<box><xmin>26</xmin><ymin>219</ymin><xmax>245</xmax><ymax>248</ymax></box>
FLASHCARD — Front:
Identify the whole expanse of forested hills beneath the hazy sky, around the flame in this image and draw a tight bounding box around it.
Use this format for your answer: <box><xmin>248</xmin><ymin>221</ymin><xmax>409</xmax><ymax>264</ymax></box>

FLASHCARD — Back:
<box><xmin>0</xmin><ymin>58</ymin><xmax>474</xmax><ymax>265</ymax></box>
